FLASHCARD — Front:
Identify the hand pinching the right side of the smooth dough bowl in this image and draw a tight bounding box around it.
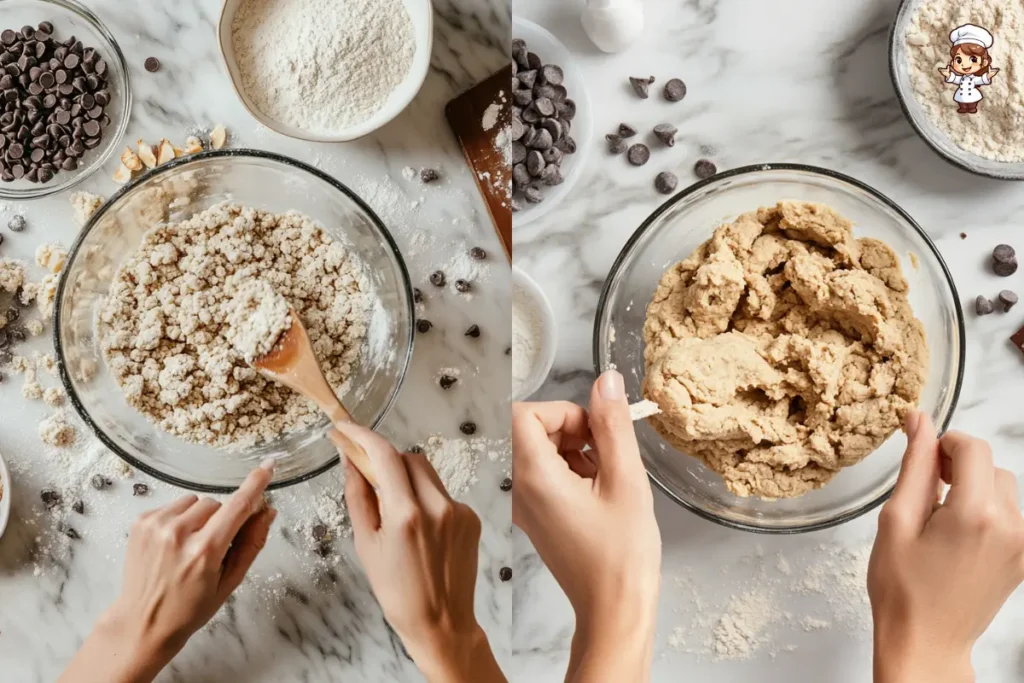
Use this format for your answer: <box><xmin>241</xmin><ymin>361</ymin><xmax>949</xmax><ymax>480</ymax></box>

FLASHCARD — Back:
<box><xmin>867</xmin><ymin>412</ymin><xmax>1024</xmax><ymax>683</ymax></box>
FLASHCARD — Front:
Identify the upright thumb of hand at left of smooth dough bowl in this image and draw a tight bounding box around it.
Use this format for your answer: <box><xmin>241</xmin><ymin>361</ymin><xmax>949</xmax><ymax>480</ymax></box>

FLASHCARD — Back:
<box><xmin>589</xmin><ymin>370</ymin><xmax>646</xmax><ymax>487</ymax></box>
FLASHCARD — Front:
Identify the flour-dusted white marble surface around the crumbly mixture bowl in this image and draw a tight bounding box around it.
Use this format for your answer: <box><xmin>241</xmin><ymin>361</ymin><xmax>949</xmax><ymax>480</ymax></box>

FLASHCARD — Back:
<box><xmin>0</xmin><ymin>0</ymin><xmax>511</xmax><ymax>683</ymax></box>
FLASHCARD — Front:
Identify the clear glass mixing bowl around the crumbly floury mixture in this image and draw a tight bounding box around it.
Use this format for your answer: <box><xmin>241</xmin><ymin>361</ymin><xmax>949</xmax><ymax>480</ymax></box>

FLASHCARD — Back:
<box><xmin>54</xmin><ymin>150</ymin><xmax>414</xmax><ymax>493</ymax></box>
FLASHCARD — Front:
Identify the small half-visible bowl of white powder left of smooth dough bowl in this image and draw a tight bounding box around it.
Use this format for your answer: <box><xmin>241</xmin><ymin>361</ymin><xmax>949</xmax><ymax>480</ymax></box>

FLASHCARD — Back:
<box><xmin>512</xmin><ymin>266</ymin><xmax>558</xmax><ymax>400</ymax></box>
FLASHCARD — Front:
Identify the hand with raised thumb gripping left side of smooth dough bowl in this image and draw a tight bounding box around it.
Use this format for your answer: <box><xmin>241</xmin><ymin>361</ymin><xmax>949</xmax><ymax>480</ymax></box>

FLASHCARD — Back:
<box><xmin>512</xmin><ymin>371</ymin><xmax>662</xmax><ymax>681</ymax></box>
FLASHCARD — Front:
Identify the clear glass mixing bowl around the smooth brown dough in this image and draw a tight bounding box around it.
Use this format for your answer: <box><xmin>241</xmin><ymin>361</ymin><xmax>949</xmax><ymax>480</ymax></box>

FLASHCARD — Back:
<box><xmin>594</xmin><ymin>164</ymin><xmax>964</xmax><ymax>533</ymax></box>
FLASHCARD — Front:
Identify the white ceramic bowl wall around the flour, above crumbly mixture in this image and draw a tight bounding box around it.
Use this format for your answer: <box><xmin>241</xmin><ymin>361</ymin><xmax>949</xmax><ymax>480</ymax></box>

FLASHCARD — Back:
<box><xmin>217</xmin><ymin>0</ymin><xmax>434</xmax><ymax>142</ymax></box>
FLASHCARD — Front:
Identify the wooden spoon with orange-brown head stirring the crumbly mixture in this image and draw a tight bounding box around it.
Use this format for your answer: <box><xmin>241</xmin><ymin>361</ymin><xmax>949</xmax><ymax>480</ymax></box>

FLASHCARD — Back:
<box><xmin>252</xmin><ymin>306</ymin><xmax>377</xmax><ymax>488</ymax></box>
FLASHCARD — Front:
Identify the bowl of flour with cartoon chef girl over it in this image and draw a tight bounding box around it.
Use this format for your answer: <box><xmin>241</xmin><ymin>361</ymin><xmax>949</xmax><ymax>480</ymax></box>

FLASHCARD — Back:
<box><xmin>889</xmin><ymin>0</ymin><xmax>1024</xmax><ymax>180</ymax></box>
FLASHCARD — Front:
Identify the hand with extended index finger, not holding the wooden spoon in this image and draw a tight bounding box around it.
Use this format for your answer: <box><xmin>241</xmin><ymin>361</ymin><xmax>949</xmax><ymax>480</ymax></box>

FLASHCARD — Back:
<box><xmin>59</xmin><ymin>463</ymin><xmax>278</xmax><ymax>683</ymax></box>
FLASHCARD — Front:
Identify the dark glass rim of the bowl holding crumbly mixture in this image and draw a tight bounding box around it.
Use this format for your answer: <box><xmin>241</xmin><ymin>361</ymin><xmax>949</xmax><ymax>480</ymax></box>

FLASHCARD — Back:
<box><xmin>50</xmin><ymin>148</ymin><xmax>416</xmax><ymax>494</ymax></box>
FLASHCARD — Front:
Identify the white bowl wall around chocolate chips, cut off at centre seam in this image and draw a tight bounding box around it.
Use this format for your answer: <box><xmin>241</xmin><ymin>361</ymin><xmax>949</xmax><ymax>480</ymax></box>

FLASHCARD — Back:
<box><xmin>512</xmin><ymin>16</ymin><xmax>594</xmax><ymax>229</ymax></box>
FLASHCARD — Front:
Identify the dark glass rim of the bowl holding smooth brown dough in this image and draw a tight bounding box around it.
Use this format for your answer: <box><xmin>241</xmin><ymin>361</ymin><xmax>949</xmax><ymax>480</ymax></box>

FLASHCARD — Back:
<box><xmin>593</xmin><ymin>163</ymin><xmax>967</xmax><ymax>536</ymax></box>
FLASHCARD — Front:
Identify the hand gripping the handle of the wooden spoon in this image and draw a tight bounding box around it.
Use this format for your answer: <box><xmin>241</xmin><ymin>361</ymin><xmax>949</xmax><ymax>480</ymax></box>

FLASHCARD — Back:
<box><xmin>336</xmin><ymin>424</ymin><xmax>505</xmax><ymax>683</ymax></box>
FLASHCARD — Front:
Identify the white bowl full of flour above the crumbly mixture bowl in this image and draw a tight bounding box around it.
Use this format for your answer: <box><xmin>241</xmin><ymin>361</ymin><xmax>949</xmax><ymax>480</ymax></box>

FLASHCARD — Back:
<box><xmin>218</xmin><ymin>0</ymin><xmax>433</xmax><ymax>142</ymax></box>
